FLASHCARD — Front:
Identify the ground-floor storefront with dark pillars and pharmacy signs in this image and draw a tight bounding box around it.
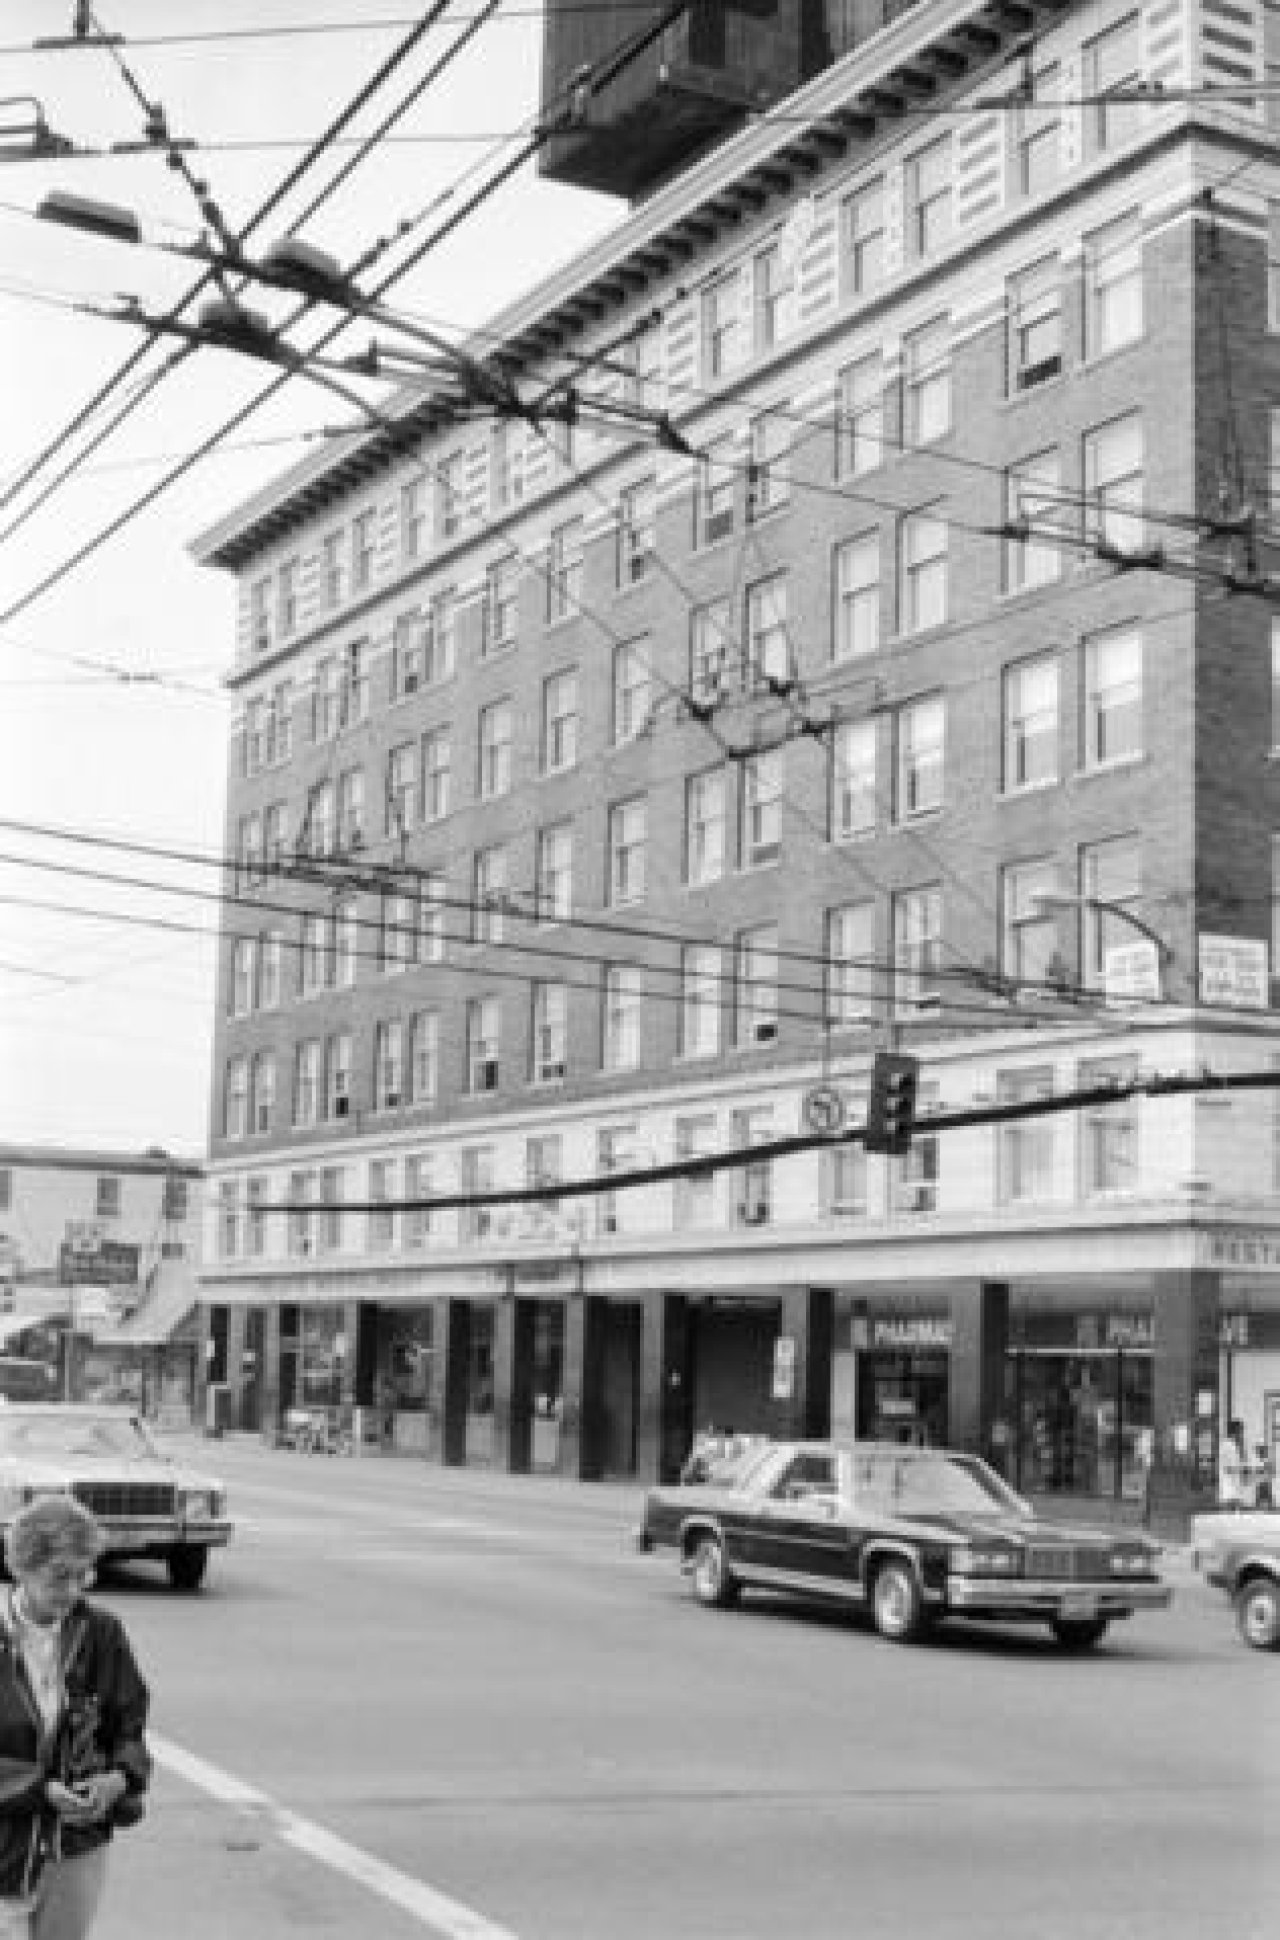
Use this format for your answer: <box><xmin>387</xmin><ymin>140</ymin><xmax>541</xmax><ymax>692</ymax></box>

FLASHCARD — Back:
<box><xmin>200</xmin><ymin>1234</ymin><xmax>1280</xmax><ymax>1519</ymax></box>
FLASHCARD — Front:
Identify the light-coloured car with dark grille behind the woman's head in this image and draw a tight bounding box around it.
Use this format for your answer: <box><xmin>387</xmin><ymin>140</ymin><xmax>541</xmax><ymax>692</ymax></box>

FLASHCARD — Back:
<box><xmin>0</xmin><ymin>1401</ymin><xmax>231</xmax><ymax>1591</ymax></box>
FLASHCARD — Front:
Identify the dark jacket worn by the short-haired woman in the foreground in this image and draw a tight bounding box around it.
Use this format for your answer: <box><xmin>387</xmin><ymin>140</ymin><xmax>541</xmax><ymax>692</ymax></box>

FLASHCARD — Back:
<box><xmin>0</xmin><ymin>1591</ymin><xmax>151</xmax><ymax>1899</ymax></box>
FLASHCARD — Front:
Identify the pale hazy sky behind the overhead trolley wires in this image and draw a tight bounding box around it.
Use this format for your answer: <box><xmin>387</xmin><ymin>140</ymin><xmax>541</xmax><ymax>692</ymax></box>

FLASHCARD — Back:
<box><xmin>0</xmin><ymin>0</ymin><xmax>623</xmax><ymax>1154</ymax></box>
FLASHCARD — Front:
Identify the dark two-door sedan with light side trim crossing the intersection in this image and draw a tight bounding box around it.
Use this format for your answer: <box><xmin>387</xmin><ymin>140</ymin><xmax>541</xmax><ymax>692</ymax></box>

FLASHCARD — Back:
<box><xmin>638</xmin><ymin>1441</ymin><xmax>1173</xmax><ymax>1651</ymax></box>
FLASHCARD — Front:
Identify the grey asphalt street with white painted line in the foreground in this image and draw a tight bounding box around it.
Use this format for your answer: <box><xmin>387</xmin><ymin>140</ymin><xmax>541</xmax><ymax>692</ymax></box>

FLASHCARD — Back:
<box><xmin>95</xmin><ymin>1441</ymin><xmax>1280</xmax><ymax>1940</ymax></box>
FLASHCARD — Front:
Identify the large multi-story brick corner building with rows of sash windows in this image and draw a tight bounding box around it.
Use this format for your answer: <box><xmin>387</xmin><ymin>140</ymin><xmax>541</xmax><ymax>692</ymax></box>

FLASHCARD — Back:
<box><xmin>198</xmin><ymin>0</ymin><xmax>1280</xmax><ymax>1504</ymax></box>
